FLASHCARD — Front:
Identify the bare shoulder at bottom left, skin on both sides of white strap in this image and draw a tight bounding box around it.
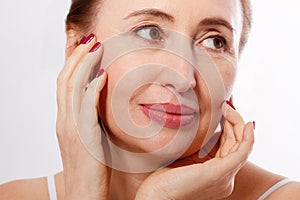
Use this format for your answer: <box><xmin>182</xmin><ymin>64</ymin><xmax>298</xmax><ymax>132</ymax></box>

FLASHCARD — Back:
<box><xmin>0</xmin><ymin>172</ymin><xmax>64</xmax><ymax>200</ymax></box>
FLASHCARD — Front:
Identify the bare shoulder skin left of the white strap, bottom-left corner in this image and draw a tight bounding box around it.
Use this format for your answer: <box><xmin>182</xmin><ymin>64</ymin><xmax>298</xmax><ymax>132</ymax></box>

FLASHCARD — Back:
<box><xmin>0</xmin><ymin>177</ymin><xmax>48</xmax><ymax>200</ymax></box>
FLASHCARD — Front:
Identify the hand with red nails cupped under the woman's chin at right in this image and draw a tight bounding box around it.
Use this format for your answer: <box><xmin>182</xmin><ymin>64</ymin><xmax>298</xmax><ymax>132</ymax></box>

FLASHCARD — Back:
<box><xmin>136</xmin><ymin>103</ymin><xmax>254</xmax><ymax>200</ymax></box>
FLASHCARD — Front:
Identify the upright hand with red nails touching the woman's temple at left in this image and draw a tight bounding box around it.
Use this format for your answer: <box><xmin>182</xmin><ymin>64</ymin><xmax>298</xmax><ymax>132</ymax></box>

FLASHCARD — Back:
<box><xmin>56</xmin><ymin>34</ymin><xmax>110</xmax><ymax>200</ymax></box>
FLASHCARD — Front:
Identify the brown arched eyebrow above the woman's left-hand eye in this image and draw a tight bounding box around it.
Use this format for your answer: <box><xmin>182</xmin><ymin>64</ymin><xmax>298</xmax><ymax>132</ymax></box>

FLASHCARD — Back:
<box><xmin>123</xmin><ymin>8</ymin><xmax>175</xmax><ymax>22</ymax></box>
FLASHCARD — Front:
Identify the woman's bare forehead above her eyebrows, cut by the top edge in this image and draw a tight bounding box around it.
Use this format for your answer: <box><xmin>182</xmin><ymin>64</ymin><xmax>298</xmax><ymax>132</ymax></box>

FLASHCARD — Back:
<box><xmin>101</xmin><ymin>0</ymin><xmax>242</xmax><ymax>31</ymax></box>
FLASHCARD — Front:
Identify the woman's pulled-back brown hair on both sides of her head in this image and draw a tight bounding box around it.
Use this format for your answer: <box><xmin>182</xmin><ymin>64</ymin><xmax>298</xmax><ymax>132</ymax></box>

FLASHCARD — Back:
<box><xmin>66</xmin><ymin>0</ymin><xmax>252</xmax><ymax>52</ymax></box>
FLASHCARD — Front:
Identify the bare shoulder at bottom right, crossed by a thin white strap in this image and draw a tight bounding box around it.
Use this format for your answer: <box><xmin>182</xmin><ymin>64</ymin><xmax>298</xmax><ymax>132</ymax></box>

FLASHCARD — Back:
<box><xmin>227</xmin><ymin>162</ymin><xmax>300</xmax><ymax>200</ymax></box>
